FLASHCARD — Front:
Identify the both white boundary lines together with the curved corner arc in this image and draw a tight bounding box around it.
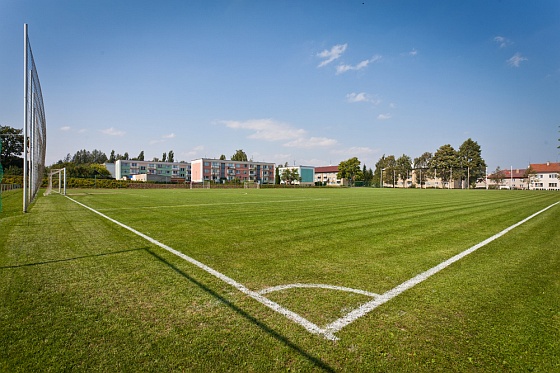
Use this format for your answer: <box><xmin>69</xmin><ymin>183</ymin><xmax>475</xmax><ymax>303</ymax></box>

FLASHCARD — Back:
<box><xmin>66</xmin><ymin>196</ymin><xmax>560</xmax><ymax>341</ymax></box>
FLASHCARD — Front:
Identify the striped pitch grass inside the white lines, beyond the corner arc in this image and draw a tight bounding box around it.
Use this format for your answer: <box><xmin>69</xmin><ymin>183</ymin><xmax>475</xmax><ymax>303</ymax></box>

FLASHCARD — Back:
<box><xmin>68</xmin><ymin>189</ymin><xmax>556</xmax><ymax>293</ymax></box>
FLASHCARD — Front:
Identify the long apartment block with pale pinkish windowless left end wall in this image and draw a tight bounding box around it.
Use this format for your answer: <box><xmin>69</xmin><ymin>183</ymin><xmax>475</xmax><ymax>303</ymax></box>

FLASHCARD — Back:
<box><xmin>191</xmin><ymin>158</ymin><xmax>274</xmax><ymax>184</ymax></box>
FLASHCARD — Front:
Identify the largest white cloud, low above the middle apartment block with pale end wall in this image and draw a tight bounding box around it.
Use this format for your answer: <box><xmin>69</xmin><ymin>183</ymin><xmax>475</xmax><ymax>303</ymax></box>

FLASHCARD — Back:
<box><xmin>221</xmin><ymin>119</ymin><xmax>306</xmax><ymax>141</ymax></box>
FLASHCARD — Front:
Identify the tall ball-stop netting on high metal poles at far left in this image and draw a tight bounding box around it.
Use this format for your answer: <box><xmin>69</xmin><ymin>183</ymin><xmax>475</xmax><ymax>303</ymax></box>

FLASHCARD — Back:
<box><xmin>23</xmin><ymin>24</ymin><xmax>47</xmax><ymax>212</ymax></box>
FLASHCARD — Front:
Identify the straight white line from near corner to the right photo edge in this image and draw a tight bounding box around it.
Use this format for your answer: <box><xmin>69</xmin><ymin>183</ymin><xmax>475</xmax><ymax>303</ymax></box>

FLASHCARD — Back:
<box><xmin>325</xmin><ymin>201</ymin><xmax>560</xmax><ymax>335</ymax></box>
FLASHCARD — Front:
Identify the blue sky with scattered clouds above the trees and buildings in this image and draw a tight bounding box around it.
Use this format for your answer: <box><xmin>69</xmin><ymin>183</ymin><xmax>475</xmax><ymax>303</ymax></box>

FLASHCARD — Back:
<box><xmin>0</xmin><ymin>0</ymin><xmax>560</xmax><ymax>171</ymax></box>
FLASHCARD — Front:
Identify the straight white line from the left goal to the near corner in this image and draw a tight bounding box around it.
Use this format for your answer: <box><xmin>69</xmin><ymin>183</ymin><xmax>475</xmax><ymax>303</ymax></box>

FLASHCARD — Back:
<box><xmin>66</xmin><ymin>196</ymin><xmax>338</xmax><ymax>341</ymax></box>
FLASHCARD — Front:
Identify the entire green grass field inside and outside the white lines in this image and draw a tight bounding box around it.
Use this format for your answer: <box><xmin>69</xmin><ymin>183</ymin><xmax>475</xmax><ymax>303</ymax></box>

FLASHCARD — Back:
<box><xmin>0</xmin><ymin>188</ymin><xmax>560</xmax><ymax>372</ymax></box>
